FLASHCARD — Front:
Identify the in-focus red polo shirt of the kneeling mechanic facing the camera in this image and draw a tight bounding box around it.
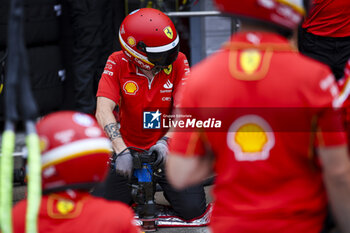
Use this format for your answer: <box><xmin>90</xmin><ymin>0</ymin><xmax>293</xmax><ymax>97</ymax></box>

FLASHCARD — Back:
<box><xmin>97</xmin><ymin>51</ymin><xmax>189</xmax><ymax>149</ymax></box>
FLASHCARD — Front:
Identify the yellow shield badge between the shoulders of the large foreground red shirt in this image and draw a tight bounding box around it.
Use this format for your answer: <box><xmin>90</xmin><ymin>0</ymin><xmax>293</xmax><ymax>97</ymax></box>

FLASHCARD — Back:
<box><xmin>239</xmin><ymin>49</ymin><xmax>262</xmax><ymax>74</ymax></box>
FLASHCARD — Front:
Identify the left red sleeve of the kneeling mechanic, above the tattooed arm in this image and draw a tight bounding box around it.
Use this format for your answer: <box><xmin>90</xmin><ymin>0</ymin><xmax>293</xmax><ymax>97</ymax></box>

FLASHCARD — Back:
<box><xmin>96</xmin><ymin>54</ymin><xmax>120</xmax><ymax>104</ymax></box>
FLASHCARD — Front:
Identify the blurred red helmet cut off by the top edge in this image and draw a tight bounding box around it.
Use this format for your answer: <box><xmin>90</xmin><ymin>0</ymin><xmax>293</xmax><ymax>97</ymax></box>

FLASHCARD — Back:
<box><xmin>214</xmin><ymin>0</ymin><xmax>305</xmax><ymax>30</ymax></box>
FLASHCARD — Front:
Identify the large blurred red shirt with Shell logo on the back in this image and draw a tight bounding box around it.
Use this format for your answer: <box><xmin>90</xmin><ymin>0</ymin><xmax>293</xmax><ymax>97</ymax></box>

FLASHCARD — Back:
<box><xmin>170</xmin><ymin>33</ymin><xmax>346</xmax><ymax>233</ymax></box>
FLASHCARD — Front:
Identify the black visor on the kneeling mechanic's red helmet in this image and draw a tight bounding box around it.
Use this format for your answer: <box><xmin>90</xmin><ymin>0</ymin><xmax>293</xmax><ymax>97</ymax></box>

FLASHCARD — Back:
<box><xmin>146</xmin><ymin>43</ymin><xmax>180</xmax><ymax>67</ymax></box>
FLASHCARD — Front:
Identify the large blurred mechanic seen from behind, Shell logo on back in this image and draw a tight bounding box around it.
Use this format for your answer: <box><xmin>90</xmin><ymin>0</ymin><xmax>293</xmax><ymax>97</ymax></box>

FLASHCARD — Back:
<box><xmin>166</xmin><ymin>0</ymin><xmax>350</xmax><ymax>233</ymax></box>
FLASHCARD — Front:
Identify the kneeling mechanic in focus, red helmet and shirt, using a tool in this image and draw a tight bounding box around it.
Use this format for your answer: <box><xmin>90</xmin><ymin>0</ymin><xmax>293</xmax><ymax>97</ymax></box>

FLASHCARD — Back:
<box><xmin>95</xmin><ymin>8</ymin><xmax>206</xmax><ymax>220</ymax></box>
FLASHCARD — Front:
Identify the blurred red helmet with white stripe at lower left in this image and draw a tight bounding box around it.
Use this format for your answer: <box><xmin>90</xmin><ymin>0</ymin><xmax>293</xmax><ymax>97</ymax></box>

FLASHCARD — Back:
<box><xmin>37</xmin><ymin>111</ymin><xmax>111</xmax><ymax>191</ymax></box>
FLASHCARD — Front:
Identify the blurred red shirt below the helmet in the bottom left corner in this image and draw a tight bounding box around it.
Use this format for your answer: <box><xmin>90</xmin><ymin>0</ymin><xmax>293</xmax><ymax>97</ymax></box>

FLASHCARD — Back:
<box><xmin>12</xmin><ymin>192</ymin><xmax>141</xmax><ymax>233</ymax></box>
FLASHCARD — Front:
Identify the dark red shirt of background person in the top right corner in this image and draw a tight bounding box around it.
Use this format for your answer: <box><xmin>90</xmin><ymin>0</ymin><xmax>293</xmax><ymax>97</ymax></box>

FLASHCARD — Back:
<box><xmin>303</xmin><ymin>0</ymin><xmax>350</xmax><ymax>37</ymax></box>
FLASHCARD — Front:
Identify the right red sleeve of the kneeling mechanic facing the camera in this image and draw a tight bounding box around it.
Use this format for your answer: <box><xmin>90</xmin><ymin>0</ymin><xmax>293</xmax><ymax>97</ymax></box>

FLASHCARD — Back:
<box><xmin>173</xmin><ymin>53</ymin><xmax>190</xmax><ymax>107</ymax></box>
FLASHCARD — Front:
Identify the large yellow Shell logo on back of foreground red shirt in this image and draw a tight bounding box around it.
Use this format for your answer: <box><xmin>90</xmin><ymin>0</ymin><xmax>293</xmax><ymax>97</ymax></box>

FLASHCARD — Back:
<box><xmin>227</xmin><ymin>115</ymin><xmax>275</xmax><ymax>161</ymax></box>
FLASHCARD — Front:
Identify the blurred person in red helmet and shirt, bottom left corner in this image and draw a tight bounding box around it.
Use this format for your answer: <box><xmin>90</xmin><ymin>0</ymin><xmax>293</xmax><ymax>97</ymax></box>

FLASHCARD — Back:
<box><xmin>13</xmin><ymin>111</ymin><xmax>141</xmax><ymax>233</ymax></box>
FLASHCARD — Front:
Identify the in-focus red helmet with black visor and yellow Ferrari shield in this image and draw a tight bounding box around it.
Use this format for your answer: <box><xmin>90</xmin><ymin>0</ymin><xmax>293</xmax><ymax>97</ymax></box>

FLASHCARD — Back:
<box><xmin>119</xmin><ymin>8</ymin><xmax>180</xmax><ymax>70</ymax></box>
